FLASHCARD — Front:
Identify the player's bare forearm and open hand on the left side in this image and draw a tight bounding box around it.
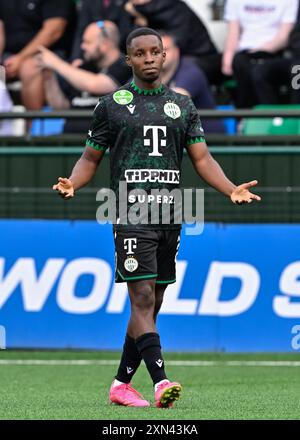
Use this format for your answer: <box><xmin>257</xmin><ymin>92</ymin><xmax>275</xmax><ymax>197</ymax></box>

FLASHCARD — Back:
<box><xmin>53</xmin><ymin>146</ymin><xmax>104</xmax><ymax>200</ymax></box>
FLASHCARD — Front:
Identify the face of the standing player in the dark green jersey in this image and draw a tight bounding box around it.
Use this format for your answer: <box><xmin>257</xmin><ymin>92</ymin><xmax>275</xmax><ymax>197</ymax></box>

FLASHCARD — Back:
<box><xmin>126</xmin><ymin>35</ymin><xmax>166</xmax><ymax>82</ymax></box>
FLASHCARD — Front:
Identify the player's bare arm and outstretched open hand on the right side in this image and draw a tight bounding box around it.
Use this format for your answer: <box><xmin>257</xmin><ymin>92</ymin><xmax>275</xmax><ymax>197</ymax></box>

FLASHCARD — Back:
<box><xmin>188</xmin><ymin>142</ymin><xmax>261</xmax><ymax>204</ymax></box>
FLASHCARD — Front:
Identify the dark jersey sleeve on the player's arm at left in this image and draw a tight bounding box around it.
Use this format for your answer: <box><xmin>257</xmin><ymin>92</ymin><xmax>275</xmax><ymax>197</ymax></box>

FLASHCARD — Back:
<box><xmin>86</xmin><ymin>98</ymin><xmax>109</xmax><ymax>151</ymax></box>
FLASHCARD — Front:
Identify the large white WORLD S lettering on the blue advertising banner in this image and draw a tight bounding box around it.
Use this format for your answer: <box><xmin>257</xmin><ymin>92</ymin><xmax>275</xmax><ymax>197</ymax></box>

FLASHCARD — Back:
<box><xmin>0</xmin><ymin>258</ymin><xmax>300</xmax><ymax>318</ymax></box>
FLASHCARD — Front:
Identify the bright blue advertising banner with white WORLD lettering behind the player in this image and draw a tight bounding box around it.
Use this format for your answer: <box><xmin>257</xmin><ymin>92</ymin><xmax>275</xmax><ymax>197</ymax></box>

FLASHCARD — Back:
<box><xmin>0</xmin><ymin>220</ymin><xmax>300</xmax><ymax>352</ymax></box>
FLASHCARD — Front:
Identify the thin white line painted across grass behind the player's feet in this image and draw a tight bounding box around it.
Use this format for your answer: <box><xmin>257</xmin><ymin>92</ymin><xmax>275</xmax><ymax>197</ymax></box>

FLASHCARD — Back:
<box><xmin>0</xmin><ymin>359</ymin><xmax>300</xmax><ymax>367</ymax></box>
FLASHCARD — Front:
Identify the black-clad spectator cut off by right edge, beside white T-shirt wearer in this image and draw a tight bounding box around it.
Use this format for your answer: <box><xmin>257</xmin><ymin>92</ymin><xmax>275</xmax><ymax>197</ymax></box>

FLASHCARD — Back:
<box><xmin>254</xmin><ymin>18</ymin><xmax>300</xmax><ymax>104</ymax></box>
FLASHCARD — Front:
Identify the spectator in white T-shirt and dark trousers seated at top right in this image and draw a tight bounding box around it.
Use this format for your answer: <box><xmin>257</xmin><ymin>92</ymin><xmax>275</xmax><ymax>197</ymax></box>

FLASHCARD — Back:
<box><xmin>222</xmin><ymin>0</ymin><xmax>298</xmax><ymax>108</ymax></box>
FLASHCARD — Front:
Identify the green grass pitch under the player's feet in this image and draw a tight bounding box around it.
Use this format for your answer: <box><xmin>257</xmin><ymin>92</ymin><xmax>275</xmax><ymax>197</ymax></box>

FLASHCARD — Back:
<box><xmin>0</xmin><ymin>350</ymin><xmax>300</xmax><ymax>420</ymax></box>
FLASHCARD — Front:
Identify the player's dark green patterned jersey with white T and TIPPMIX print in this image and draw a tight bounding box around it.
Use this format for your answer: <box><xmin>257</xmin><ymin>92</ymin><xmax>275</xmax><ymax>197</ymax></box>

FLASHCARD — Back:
<box><xmin>87</xmin><ymin>82</ymin><xmax>204</xmax><ymax>228</ymax></box>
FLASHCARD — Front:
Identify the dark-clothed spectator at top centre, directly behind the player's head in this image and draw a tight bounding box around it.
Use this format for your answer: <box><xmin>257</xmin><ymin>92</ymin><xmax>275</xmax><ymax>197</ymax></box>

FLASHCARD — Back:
<box><xmin>71</xmin><ymin>0</ymin><xmax>222</xmax><ymax>83</ymax></box>
